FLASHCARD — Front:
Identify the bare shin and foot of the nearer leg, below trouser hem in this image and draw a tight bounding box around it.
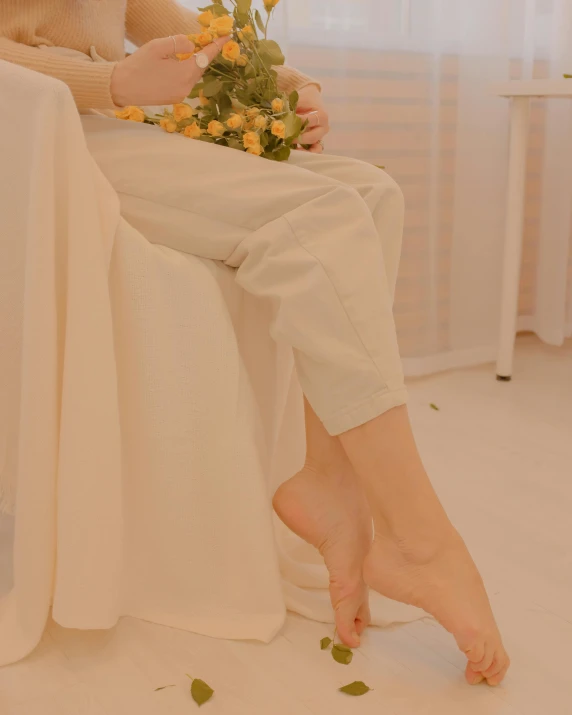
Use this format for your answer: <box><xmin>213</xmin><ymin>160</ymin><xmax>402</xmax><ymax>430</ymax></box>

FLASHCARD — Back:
<box><xmin>340</xmin><ymin>407</ymin><xmax>509</xmax><ymax>685</ymax></box>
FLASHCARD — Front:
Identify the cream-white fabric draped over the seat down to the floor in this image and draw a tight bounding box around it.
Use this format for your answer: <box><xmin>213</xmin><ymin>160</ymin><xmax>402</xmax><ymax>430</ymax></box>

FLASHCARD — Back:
<box><xmin>0</xmin><ymin>62</ymin><xmax>422</xmax><ymax>665</ymax></box>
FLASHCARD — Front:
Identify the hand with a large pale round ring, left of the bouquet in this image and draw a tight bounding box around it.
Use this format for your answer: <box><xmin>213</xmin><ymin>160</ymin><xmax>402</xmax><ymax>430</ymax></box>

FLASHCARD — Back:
<box><xmin>111</xmin><ymin>35</ymin><xmax>229</xmax><ymax>107</ymax></box>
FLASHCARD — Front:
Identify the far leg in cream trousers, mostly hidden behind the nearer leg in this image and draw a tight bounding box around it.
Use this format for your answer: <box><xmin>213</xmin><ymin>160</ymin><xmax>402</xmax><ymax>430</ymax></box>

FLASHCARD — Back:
<box><xmin>273</xmin><ymin>158</ymin><xmax>404</xmax><ymax>647</ymax></box>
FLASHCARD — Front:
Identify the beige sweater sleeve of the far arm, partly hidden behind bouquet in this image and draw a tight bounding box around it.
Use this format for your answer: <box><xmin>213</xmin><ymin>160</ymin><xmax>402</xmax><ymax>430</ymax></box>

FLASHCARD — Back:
<box><xmin>126</xmin><ymin>0</ymin><xmax>321</xmax><ymax>92</ymax></box>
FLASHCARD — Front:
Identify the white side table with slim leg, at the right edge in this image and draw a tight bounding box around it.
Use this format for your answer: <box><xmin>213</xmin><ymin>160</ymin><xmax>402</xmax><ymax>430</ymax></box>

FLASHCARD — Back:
<box><xmin>493</xmin><ymin>79</ymin><xmax>572</xmax><ymax>382</ymax></box>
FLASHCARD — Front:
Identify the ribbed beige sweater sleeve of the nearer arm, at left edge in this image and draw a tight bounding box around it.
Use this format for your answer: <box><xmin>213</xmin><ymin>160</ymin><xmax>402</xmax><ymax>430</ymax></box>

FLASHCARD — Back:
<box><xmin>0</xmin><ymin>37</ymin><xmax>115</xmax><ymax>109</ymax></box>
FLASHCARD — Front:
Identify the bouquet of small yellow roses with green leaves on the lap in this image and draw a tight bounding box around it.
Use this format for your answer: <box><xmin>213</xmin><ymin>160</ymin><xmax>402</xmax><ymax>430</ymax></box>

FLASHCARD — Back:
<box><xmin>117</xmin><ymin>0</ymin><xmax>305</xmax><ymax>161</ymax></box>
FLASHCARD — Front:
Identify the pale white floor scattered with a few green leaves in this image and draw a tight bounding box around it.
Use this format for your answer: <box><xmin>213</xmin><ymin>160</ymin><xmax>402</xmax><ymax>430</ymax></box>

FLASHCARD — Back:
<box><xmin>0</xmin><ymin>337</ymin><xmax>572</xmax><ymax>715</ymax></box>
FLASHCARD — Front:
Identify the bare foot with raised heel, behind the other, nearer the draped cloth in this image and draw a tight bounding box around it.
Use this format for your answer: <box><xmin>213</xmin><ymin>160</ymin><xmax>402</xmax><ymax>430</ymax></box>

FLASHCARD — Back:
<box><xmin>273</xmin><ymin>466</ymin><xmax>373</xmax><ymax>648</ymax></box>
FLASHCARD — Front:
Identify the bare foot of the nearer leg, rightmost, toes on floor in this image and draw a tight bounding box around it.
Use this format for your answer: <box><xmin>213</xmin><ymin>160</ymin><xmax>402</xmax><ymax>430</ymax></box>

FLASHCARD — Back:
<box><xmin>364</xmin><ymin>527</ymin><xmax>510</xmax><ymax>685</ymax></box>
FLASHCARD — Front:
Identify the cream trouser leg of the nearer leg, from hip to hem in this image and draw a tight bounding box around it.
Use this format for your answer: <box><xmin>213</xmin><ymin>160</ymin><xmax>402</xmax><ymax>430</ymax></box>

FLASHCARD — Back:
<box><xmin>83</xmin><ymin>117</ymin><xmax>406</xmax><ymax>434</ymax></box>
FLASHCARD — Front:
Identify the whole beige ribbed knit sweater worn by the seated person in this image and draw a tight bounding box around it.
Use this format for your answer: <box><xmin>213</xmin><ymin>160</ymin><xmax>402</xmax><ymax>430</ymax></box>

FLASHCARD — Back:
<box><xmin>0</xmin><ymin>0</ymin><xmax>317</xmax><ymax>109</ymax></box>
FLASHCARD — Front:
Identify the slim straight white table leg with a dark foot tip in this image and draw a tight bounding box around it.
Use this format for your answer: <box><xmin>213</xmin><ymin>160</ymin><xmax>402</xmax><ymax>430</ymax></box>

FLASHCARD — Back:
<box><xmin>497</xmin><ymin>97</ymin><xmax>530</xmax><ymax>382</ymax></box>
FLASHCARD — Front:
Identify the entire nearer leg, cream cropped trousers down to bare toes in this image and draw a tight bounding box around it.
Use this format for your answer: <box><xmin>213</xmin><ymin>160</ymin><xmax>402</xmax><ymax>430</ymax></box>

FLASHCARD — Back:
<box><xmin>88</xmin><ymin>118</ymin><xmax>506</xmax><ymax>682</ymax></box>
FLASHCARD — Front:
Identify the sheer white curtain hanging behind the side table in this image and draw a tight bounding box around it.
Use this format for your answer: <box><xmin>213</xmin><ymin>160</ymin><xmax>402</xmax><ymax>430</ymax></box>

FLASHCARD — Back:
<box><xmin>202</xmin><ymin>0</ymin><xmax>572</xmax><ymax>374</ymax></box>
